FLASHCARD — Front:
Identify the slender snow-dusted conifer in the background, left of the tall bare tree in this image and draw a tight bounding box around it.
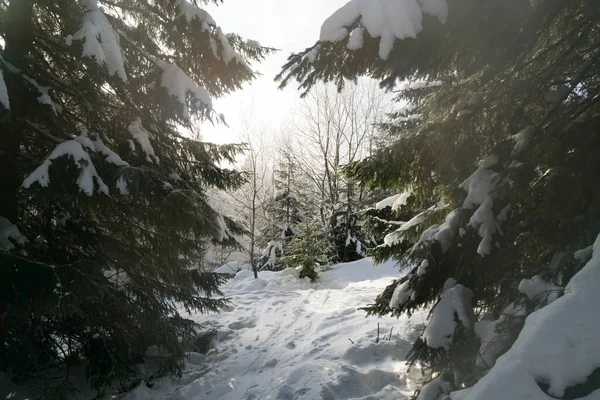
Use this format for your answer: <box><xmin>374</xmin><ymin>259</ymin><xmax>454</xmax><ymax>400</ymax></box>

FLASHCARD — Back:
<box><xmin>260</xmin><ymin>151</ymin><xmax>304</xmax><ymax>271</ymax></box>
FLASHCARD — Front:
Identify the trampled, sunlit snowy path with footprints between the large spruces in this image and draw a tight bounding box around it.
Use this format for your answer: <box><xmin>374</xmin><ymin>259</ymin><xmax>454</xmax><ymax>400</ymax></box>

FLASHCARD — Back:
<box><xmin>127</xmin><ymin>260</ymin><xmax>424</xmax><ymax>400</ymax></box>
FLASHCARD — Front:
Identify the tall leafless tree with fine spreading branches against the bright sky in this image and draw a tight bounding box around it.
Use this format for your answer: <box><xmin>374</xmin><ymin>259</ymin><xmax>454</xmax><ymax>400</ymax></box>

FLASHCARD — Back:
<box><xmin>287</xmin><ymin>81</ymin><xmax>391</xmax><ymax>260</ymax></box>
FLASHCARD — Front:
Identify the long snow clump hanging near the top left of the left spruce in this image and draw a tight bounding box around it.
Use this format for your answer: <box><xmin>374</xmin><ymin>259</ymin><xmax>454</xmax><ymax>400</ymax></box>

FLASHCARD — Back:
<box><xmin>66</xmin><ymin>0</ymin><xmax>127</xmax><ymax>82</ymax></box>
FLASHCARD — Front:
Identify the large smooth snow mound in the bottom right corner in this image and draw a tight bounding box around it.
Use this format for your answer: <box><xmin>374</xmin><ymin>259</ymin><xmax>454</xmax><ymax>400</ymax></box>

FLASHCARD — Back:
<box><xmin>464</xmin><ymin>236</ymin><xmax>600</xmax><ymax>400</ymax></box>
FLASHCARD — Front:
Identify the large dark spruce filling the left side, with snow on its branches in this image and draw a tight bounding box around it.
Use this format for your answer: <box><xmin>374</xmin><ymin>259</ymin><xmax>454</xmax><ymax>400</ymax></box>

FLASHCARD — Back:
<box><xmin>0</xmin><ymin>0</ymin><xmax>271</xmax><ymax>390</ymax></box>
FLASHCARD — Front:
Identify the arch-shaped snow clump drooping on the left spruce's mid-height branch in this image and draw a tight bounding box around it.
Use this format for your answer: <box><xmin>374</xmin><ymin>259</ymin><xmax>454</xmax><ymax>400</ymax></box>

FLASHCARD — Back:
<box><xmin>23</xmin><ymin>139</ymin><xmax>109</xmax><ymax>196</ymax></box>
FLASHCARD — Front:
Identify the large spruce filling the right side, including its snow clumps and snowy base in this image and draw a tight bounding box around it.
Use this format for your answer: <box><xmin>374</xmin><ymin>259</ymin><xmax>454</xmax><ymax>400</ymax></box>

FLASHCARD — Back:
<box><xmin>279</xmin><ymin>0</ymin><xmax>600</xmax><ymax>400</ymax></box>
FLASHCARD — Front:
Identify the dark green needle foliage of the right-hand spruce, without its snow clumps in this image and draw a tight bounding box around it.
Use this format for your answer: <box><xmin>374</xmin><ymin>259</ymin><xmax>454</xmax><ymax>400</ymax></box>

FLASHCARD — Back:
<box><xmin>278</xmin><ymin>0</ymin><xmax>600</xmax><ymax>398</ymax></box>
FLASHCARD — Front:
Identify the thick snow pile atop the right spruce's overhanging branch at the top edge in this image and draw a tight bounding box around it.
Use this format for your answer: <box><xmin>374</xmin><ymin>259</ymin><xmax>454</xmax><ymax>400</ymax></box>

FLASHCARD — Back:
<box><xmin>320</xmin><ymin>0</ymin><xmax>448</xmax><ymax>60</ymax></box>
